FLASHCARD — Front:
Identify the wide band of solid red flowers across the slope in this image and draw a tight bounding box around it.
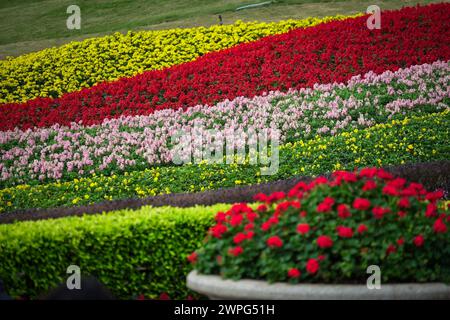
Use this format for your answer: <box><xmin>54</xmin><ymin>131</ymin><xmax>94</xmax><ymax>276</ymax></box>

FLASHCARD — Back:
<box><xmin>0</xmin><ymin>4</ymin><xmax>450</xmax><ymax>131</ymax></box>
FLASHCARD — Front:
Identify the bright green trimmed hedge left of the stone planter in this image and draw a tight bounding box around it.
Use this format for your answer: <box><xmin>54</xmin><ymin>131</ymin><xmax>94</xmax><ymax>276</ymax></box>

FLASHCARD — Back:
<box><xmin>0</xmin><ymin>204</ymin><xmax>229</xmax><ymax>298</ymax></box>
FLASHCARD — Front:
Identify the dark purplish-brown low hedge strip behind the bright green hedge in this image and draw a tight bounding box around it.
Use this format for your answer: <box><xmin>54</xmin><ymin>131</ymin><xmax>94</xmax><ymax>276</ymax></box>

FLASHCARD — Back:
<box><xmin>0</xmin><ymin>160</ymin><xmax>450</xmax><ymax>224</ymax></box>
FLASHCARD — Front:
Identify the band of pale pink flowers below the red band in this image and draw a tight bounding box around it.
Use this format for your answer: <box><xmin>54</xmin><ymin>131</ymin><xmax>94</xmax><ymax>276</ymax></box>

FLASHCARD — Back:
<box><xmin>0</xmin><ymin>62</ymin><xmax>450</xmax><ymax>186</ymax></box>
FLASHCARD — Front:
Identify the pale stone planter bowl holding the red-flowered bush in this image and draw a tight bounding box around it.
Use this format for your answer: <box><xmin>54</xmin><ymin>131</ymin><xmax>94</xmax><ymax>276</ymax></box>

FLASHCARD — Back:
<box><xmin>187</xmin><ymin>270</ymin><xmax>450</xmax><ymax>300</ymax></box>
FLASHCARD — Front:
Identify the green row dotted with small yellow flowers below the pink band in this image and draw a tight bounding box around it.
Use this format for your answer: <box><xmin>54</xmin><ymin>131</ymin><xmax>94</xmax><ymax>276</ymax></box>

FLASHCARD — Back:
<box><xmin>0</xmin><ymin>109</ymin><xmax>450</xmax><ymax>211</ymax></box>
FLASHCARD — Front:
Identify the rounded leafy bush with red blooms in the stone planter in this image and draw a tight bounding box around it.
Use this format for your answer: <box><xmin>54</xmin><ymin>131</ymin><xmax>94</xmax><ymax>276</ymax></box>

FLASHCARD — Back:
<box><xmin>189</xmin><ymin>168</ymin><xmax>450</xmax><ymax>283</ymax></box>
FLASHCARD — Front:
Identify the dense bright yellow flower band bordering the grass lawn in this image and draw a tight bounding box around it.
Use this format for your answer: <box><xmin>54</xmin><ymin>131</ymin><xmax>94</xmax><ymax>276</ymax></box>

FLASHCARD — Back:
<box><xmin>0</xmin><ymin>16</ymin><xmax>358</xmax><ymax>103</ymax></box>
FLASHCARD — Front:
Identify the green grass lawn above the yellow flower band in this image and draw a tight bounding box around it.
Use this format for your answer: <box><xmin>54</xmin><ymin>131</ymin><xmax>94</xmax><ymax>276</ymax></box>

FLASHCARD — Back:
<box><xmin>0</xmin><ymin>0</ymin><xmax>442</xmax><ymax>58</ymax></box>
